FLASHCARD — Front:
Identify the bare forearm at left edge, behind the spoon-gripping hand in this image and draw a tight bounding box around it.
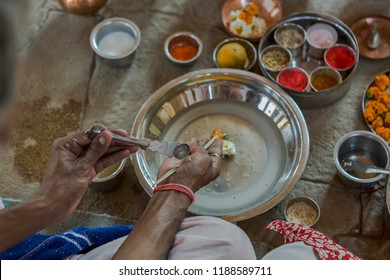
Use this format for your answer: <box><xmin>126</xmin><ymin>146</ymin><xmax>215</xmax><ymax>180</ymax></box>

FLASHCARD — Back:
<box><xmin>0</xmin><ymin>198</ymin><xmax>54</xmax><ymax>252</ymax></box>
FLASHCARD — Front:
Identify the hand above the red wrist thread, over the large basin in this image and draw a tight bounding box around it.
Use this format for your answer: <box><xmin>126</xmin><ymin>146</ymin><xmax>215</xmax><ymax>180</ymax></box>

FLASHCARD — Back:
<box><xmin>157</xmin><ymin>138</ymin><xmax>222</xmax><ymax>192</ymax></box>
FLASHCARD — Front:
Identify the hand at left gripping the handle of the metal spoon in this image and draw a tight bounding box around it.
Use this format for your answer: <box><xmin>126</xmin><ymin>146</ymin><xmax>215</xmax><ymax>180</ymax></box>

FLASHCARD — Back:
<box><xmin>36</xmin><ymin>130</ymin><xmax>138</xmax><ymax>221</ymax></box>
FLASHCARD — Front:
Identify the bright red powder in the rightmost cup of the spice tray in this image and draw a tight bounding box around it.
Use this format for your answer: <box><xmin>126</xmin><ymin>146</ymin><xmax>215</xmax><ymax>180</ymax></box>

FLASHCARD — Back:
<box><xmin>325</xmin><ymin>45</ymin><xmax>356</xmax><ymax>71</ymax></box>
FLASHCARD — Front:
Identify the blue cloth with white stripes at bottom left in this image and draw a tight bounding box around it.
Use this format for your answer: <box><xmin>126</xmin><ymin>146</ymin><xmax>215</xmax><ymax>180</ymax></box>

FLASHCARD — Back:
<box><xmin>0</xmin><ymin>225</ymin><xmax>133</xmax><ymax>260</ymax></box>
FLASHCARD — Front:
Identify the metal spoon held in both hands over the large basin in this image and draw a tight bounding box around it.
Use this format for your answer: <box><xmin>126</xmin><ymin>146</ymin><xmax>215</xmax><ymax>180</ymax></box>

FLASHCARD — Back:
<box><xmin>85</xmin><ymin>124</ymin><xmax>191</xmax><ymax>159</ymax></box>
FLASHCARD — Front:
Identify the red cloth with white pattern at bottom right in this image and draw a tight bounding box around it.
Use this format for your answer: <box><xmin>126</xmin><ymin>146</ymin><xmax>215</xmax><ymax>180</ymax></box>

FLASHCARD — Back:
<box><xmin>266</xmin><ymin>220</ymin><xmax>361</xmax><ymax>260</ymax></box>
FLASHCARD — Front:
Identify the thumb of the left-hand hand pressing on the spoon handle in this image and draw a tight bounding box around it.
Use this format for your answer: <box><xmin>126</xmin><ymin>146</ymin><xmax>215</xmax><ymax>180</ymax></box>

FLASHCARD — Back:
<box><xmin>84</xmin><ymin>131</ymin><xmax>112</xmax><ymax>166</ymax></box>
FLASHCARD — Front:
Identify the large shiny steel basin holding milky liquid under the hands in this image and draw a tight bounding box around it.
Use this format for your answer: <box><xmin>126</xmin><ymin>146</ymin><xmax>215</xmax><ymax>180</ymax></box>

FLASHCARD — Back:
<box><xmin>131</xmin><ymin>69</ymin><xmax>309</xmax><ymax>221</ymax></box>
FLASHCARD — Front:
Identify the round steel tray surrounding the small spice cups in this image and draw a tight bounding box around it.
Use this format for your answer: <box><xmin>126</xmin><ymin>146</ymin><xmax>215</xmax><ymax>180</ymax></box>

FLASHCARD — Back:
<box><xmin>258</xmin><ymin>13</ymin><xmax>359</xmax><ymax>109</ymax></box>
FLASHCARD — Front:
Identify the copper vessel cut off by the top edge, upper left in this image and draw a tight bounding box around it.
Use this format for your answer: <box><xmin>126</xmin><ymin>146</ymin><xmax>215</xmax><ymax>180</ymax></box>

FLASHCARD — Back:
<box><xmin>59</xmin><ymin>0</ymin><xmax>107</xmax><ymax>15</ymax></box>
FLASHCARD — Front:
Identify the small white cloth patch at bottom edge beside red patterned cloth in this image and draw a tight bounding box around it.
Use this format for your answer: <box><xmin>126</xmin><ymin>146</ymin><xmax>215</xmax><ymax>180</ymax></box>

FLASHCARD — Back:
<box><xmin>262</xmin><ymin>242</ymin><xmax>319</xmax><ymax>260</ymax></box>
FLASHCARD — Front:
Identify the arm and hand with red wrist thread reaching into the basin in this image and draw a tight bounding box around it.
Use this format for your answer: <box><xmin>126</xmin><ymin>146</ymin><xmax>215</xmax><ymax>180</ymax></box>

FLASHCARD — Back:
<box><xmin>114</xmin><ymin>139</ymin><xmax>222</xmax><ymax>259</ymax></box>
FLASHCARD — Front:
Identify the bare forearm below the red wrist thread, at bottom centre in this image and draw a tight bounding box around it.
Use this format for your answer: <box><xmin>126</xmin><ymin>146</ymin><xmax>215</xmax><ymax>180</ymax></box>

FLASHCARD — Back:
<box><xmin>114</xmin><ymin>191</ymin><xmax>190</xmax><ymax>259</ymax></box>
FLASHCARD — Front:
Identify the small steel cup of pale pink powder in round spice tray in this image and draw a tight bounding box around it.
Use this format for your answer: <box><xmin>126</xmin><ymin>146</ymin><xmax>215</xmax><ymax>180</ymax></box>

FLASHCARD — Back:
<box><xmin>307</xmin><ymin>23</ymin><xmax>338</xmax><ymax>59</ymax></box>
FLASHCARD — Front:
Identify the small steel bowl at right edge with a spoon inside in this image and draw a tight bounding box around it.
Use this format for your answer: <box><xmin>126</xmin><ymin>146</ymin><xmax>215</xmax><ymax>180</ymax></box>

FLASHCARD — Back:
<box><xmin>333</xmin><ymin>130</ymin><xmax>390</xmax><ymax>190</ymax></box>
